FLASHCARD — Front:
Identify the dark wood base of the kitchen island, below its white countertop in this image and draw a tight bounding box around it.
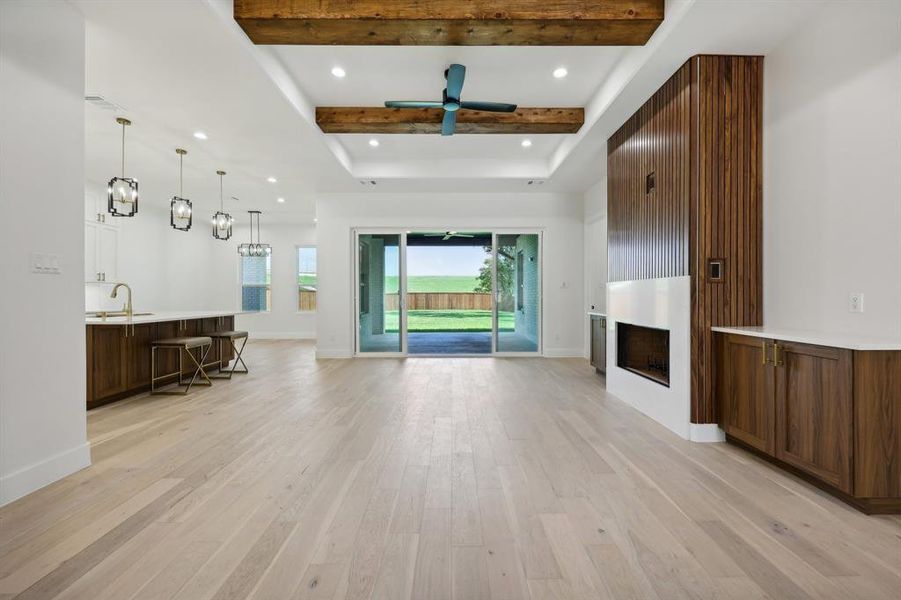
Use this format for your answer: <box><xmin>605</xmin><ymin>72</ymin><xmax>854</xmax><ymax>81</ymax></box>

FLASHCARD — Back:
<box><xmin>86</xmin><ymin>316</ymin><xmax>235</xmax><ymax>408</ymax></box>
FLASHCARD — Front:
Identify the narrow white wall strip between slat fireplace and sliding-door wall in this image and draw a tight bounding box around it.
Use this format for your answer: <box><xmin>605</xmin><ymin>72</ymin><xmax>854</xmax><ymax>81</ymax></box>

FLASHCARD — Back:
<box><xmin>583</xmin><ymin>178</ymin><xmax>607</xmax><ymax>357</ymax></box>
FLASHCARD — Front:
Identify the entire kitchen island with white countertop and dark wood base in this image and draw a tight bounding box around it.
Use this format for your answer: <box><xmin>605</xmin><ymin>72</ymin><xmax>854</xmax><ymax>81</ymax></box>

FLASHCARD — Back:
<box><xmin>85</xmin><ymin>311</ymin><xmax>238</xmax><ymax>408</ymax></box>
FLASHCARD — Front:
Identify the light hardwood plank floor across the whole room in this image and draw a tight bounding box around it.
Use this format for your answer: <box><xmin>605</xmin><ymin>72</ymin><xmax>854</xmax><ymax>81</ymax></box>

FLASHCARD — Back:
<box><xmin>0</xmin><ymin>342</ymin><xmax>901</xmax><ymax>600</ymax></box>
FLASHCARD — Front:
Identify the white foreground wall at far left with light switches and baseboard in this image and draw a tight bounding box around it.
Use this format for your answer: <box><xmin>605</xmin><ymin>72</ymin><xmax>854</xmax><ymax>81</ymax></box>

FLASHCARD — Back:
<box><xmin>0</xmin><ymin>0</ymin><xmax>90</xmax><ymax>504</ymax></box>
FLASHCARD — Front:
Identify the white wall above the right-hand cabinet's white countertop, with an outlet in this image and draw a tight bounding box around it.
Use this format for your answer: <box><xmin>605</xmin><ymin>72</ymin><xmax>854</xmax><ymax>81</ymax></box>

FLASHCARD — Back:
<box><xmin>763</xmin><ymin>0</ymin><xmax>901</xmax><ymax>335</ymax></box>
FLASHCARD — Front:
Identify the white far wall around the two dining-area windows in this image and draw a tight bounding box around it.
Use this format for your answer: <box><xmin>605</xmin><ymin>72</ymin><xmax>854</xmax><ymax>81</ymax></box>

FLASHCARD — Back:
<box><xmin>232</xmin><ymin>224</ymin><xmax>316</xmax><ymax>339</ymax></box>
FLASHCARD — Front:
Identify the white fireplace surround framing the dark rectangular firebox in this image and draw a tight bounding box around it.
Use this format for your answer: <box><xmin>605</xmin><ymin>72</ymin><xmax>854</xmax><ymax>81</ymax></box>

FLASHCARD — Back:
<box><xmin>607</xmin><ymin>277</ymin><xmax>725</xmax><ymax>442</ymax></box>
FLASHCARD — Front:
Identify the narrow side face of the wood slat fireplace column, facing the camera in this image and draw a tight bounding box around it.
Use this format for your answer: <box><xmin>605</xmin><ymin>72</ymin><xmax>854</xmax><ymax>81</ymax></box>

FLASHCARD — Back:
<box><xmin>689</xmin><ymin>56</ymin><xmax>763</xmax><ymax>423</ymax></box>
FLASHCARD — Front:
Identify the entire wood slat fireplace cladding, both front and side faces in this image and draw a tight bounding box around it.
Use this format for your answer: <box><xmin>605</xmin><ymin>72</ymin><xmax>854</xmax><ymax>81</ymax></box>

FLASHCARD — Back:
<box><xmin>607</xmin><ymin>55</ymin><xmax>763</xmax><ymax>423</ymax></box>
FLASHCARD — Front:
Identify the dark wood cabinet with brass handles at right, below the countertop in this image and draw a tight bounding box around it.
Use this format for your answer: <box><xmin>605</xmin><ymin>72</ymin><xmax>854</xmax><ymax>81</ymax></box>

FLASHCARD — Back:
<box><xmin>716</xmin><ymin>333</ymin><xmax>901</xmax><ymax>512</ymax></box>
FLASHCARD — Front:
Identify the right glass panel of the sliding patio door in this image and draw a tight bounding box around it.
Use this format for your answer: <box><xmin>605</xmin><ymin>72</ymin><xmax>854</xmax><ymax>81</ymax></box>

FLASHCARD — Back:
<box><xmin>494</xmin><ymin>233</ymin><xmax>541</xmax><ymax>352</ymax></box>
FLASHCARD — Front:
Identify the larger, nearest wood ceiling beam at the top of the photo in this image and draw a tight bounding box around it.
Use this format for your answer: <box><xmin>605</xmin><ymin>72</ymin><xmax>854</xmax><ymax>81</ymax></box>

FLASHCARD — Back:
<box><xmin>234</xmin><ymin>0</ymin><xmax>664</xmax><ymax>46</ymax></box>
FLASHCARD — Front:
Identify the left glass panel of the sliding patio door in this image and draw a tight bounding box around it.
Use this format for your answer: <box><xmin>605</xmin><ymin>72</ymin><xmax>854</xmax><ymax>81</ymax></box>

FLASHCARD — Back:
<box><xmin>357</xmin><ymin>233</ymin><xmax>405</xmax><ymax>353</ymax></box>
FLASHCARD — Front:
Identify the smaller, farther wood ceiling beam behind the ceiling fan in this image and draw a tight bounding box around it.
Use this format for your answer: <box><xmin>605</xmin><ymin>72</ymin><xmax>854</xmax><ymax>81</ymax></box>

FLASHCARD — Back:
<box><xmin>316</xmin><ymin>106</ymin><xmax>585</xmax><ymax>133</ymax></box>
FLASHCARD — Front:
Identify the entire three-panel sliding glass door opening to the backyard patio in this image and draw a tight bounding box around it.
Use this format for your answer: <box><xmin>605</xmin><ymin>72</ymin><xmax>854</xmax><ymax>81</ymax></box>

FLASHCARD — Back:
<box><xmin>354</xmin><ymin>230</ymin><xmax>541</xmax><ymax>356</ymax></box>
